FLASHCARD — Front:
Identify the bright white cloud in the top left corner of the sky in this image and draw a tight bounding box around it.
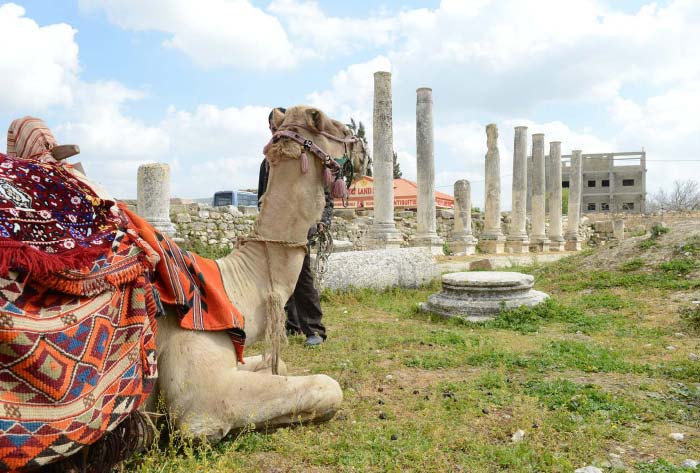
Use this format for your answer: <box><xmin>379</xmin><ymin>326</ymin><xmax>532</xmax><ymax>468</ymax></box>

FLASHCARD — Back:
<box><xmin>0</xmin><ymin>3</ymin><xmax>79</xmax><ymax>114</ymax></box>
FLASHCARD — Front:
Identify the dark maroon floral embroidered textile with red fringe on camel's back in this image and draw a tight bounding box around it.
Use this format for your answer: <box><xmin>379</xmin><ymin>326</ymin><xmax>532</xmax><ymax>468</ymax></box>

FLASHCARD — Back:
<box><xmin>0</xmin><ymin>154</ymin><xmax>125</xmax><ymax>275</ymax></box>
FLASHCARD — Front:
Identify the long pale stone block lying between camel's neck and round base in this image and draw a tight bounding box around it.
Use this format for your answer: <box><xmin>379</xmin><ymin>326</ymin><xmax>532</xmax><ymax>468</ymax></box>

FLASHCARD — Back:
<box><xmin>323</xmin><ymin>248</ymin><xmax>440</xmax><ymax>290</ymax></box>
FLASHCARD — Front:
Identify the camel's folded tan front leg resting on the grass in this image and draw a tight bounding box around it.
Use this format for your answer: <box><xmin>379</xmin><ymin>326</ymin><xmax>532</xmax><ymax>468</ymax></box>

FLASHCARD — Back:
<box><xmin>158</xmin><ymin>321</ymin><xmax>343</xmax><ymax>441</ymax></box>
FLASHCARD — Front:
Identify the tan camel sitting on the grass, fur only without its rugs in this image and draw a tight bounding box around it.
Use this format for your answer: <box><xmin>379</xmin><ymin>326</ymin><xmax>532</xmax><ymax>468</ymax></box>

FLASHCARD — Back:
<box><xmin>146</xmin><ymin>106</ymin><xmax>366</xmax><ymax>442</ymax></box>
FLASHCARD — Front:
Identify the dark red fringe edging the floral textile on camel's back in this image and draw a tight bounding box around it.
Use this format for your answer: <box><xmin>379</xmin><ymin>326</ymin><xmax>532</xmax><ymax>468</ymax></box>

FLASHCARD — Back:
<box><xmin>0</xmin><ymin>240</ymin><xmax>109</xmax><ymax>277</ymax></box>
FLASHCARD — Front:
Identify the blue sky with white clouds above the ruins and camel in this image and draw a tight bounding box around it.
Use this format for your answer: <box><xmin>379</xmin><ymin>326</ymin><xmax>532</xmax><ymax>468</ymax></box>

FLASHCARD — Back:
<box><xmin>0</xmin><ymin>0</ymin><xmax>700</xmax><ymax>209</ymax></box>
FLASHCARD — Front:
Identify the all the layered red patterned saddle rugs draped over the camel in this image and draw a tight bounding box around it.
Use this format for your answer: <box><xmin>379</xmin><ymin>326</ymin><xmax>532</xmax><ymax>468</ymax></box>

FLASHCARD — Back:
<box><xmin>0</xmin><ymin>150</ymin><xmax>245</xmax><ymax>471</ymax></box>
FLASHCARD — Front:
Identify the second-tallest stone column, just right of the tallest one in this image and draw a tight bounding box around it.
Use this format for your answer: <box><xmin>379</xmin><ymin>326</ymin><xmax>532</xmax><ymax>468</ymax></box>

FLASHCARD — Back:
<box><xmin>411</xmin><ymin>87</ymin><xmax>444</xmax><ymax>254</ymax></box>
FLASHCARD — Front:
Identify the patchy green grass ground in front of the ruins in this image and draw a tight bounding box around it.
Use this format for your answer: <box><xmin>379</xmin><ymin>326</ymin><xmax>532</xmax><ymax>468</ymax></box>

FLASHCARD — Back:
<box><xmin>127</xmin><ymin>247</ymin><xmax>700</xmax><ymax>473</ymax></box>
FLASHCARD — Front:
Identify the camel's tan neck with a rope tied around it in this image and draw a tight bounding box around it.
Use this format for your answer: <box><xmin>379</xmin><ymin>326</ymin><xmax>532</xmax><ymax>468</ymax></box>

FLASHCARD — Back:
<box><xmin>218</xmin><ymin>161</ymin><xmax>313</xmax><ymax>343</ymax></box>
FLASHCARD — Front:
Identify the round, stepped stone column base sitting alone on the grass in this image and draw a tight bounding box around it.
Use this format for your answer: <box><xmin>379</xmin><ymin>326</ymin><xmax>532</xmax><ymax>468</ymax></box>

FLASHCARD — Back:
<box><xmin>421</xmin><ymin>271</ymin><xmax>549</xmax><ymax>322</ymax></box>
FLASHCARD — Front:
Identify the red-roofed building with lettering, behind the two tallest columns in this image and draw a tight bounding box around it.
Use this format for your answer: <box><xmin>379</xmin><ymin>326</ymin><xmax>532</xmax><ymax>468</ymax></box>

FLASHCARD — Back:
<box><xmin>334</xmin><ymin>176</ymin><xmax>454</xmax><ymax>209</ymax></box>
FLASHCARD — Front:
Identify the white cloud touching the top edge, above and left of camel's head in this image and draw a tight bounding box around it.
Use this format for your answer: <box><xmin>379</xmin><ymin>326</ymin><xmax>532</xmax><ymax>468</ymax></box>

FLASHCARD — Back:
<box><xmin>80</xmin><ymin>0</ymin><xmax>297</xmax><ymax>70</ymax></box>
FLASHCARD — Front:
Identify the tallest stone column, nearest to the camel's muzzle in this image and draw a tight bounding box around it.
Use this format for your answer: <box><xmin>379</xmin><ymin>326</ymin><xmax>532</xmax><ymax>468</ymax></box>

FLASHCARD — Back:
<box><xmin>368</xmin><ymin>72</ymin><xmax>403</xmax><ymax>248</ymax></box>
